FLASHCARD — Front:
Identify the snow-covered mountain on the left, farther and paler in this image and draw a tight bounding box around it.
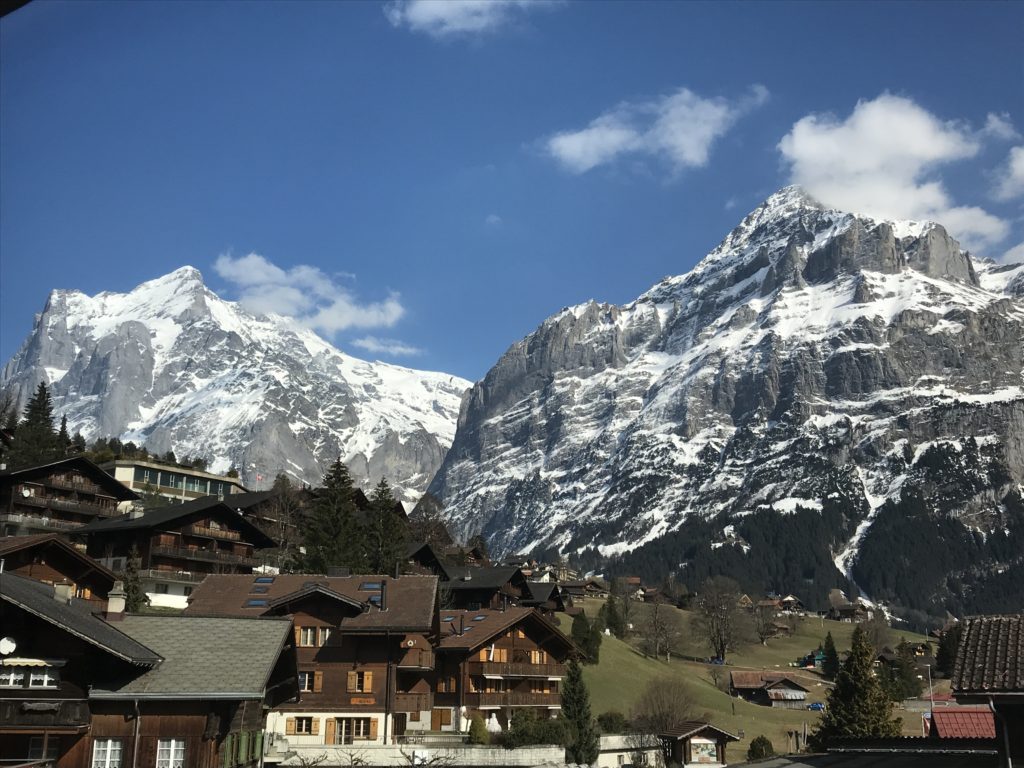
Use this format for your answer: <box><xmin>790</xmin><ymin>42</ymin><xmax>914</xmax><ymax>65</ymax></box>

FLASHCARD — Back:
<box><xmin>0</xmin><ymin>267</ymin><xmax>469</xmax><ymax>502</ymax></box>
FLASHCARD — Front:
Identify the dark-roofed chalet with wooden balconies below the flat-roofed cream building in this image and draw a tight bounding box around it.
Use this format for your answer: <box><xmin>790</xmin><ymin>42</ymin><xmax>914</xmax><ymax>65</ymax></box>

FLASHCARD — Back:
<box><xmin>76</xmin><ymin>497</ymin><xmax>275</xmax><ymax>608</ymax></box>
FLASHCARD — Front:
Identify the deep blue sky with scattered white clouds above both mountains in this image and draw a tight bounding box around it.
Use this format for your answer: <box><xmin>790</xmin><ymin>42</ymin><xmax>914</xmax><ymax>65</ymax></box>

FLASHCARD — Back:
<box><xmin>0</xmin><ymin>0</ymin><xmax>1024</xmax><ymax>379</ymax></box>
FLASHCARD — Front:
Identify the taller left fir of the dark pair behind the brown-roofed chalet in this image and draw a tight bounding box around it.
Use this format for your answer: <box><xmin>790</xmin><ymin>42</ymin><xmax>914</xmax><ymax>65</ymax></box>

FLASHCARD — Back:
<box><xmin>305</xmin><ymin>459</ymin><xmax>366</xmax><ymax>573</ymax></box>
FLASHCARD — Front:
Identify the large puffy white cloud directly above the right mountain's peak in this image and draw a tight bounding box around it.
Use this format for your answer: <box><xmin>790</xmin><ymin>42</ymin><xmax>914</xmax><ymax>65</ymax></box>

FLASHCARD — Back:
<box><xmin>778</xmin><ymin>93</ymin><xmax>1009</xmax><ymax>247</ymax></box>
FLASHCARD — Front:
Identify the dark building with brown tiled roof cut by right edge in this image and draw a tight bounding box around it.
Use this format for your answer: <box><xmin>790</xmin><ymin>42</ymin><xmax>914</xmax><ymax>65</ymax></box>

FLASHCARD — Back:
<box><xmin>951</xmin><ymin>613</ymin><xmax>1024</xmax><ymax>766</ymax></box>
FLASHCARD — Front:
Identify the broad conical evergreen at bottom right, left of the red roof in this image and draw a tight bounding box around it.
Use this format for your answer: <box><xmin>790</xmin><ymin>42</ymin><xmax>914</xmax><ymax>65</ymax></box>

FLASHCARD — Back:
<box><xmin>810</xmin><ymin>625</ymin><xmax>901</xmax><ymax>751</ymax></box>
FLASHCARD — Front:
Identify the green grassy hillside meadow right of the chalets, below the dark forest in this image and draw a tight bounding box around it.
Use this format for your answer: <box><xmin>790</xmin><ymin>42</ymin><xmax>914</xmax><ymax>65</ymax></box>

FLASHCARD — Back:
<box><xmin>559</xmin><ymin>599</ymin><xmax>937</xmax><ymax>763</ymax></box>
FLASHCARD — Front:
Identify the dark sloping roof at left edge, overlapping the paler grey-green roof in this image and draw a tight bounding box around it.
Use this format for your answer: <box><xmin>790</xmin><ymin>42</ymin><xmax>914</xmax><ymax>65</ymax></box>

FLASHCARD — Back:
<box><xmin>0</xmin><ymin>573</ymin><xmax>161</xmax><ymax>666</ymax></box>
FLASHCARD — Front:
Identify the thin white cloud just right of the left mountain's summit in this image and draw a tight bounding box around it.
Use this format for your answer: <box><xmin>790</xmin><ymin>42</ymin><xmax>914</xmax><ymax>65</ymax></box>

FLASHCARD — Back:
<box><xmin>213</xmin><ymin>253</ymin><xmax>406</xmax><ymax>335</ymax></box>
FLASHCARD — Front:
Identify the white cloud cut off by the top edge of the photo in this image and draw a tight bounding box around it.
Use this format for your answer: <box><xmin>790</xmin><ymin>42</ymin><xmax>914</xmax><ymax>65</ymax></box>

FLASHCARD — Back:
<box><xmin>384</xmin><ymin>0</ymin><xmax>554</xmax><ymax>39</ymax></box>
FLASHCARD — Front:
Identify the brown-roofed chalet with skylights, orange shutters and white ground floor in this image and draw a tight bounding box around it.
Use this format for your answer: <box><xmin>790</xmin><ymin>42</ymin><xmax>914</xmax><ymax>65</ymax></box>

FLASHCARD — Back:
<box><xmin>185</xmin><ymin>573</ymin><xmax>438</xmax><ymax>752</ymax></box>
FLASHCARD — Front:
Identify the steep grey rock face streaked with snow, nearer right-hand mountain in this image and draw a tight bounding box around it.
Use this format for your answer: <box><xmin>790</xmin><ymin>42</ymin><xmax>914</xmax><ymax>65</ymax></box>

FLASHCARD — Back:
<box><xmin>429</xmin><ymin>188</ymin><xmax>1024</xmax><ymax>589</ymax></box>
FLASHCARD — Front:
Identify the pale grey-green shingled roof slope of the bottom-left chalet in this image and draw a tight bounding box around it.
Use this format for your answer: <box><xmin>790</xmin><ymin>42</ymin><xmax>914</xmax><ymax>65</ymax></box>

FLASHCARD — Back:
<box><xmin>89</xmin><ymin>615</ymin><xmax>292</xmax><ymax>699</ymax></box>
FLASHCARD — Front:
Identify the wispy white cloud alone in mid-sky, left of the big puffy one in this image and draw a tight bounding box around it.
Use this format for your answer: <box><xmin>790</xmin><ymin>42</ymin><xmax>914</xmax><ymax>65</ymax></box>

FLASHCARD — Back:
<box><xmin>544</xmin><ymin>85</ymin><xmax>768</xmax><ymax>173</ymax></box>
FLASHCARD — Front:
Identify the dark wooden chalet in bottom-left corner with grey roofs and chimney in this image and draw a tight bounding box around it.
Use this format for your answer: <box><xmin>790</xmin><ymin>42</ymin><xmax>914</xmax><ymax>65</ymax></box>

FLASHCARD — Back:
<box><xmin>0</xmin><ymin>572</ymin><xmax>297</xmax><ymax>768</ymax></box>
